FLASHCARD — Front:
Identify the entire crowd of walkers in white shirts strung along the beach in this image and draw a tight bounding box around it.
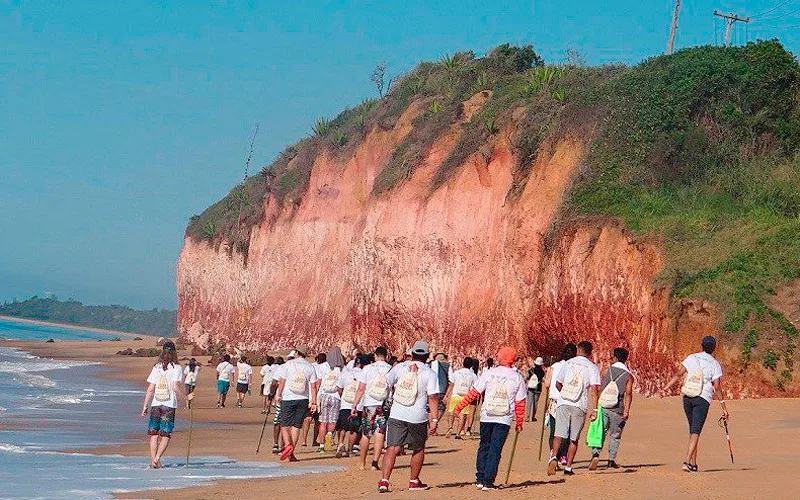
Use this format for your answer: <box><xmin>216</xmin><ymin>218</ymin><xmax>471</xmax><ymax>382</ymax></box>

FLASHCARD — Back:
<box><xmin>142</xmin><ymin>337</ymin><xmax>729</xmax><ymax>492</ymax></box>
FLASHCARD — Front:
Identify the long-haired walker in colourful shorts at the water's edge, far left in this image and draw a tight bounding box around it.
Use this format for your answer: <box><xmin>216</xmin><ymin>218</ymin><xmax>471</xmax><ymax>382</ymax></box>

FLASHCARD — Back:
<box><xmin>142</xmin><ymin>340</ymin><xmax>194</xmax><ymax>469</ymax></box>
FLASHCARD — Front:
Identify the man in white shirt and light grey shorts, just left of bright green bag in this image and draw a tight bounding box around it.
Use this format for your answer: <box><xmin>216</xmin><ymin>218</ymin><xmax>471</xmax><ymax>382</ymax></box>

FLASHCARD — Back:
<box><xmin>547</xmin><ymin>341</ymin><xmax>600</xmax><ymax>476</ymax></box>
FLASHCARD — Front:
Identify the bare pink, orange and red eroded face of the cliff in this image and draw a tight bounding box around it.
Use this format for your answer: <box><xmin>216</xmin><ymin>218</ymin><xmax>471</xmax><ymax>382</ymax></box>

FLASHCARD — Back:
<box><xmin>178</xmin><ymin>95</ymin><xmax>743</xmax><ymax>393</ymax></box>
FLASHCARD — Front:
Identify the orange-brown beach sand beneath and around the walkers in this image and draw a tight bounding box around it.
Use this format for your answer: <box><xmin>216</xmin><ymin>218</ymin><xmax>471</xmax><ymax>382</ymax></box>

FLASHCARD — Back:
<box><xmin>2</xmin><ymin>340</ymin><xmax>800</xmax><ymax>499</ymax></box>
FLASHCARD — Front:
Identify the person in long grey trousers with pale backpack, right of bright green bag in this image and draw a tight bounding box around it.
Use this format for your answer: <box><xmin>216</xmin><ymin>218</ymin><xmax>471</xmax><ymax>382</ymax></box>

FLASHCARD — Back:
<box><xmin>589</xmin><ymin>347</ymin><xmax>633</xmax><ymax>470</ymax></box>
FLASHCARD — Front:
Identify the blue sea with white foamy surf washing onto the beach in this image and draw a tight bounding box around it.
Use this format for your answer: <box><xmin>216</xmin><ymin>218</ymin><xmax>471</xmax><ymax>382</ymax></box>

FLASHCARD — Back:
<box><xmin>0</xmin><ymin>320</ymin><xmax>338</xmax><ymax>499</ymax></box>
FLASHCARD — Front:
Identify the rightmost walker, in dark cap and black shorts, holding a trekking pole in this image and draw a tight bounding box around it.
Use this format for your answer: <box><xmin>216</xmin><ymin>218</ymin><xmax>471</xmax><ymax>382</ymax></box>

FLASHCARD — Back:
<box><xmin>664</xmin><ymin>336</ymin><xmax>730</xmax><ymax>472</ymax></box>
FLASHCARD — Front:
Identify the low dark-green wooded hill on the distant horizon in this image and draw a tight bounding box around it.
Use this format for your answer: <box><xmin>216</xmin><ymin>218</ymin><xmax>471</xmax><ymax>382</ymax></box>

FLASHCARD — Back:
<box><xmin>0</xmin><ymin>297</ymin><xmax>177</xmax><ymax>336</ymax></box>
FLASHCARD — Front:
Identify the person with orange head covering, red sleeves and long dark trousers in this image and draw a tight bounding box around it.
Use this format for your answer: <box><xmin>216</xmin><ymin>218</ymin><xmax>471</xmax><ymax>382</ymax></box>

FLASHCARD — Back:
<box><xmin>455</xmin><ymin>347</ymin><xmax>528</xmax><ymax>491</ymax></box>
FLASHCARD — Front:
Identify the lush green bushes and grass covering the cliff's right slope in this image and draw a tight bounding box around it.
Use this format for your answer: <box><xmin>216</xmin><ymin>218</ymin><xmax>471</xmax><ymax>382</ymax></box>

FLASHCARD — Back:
<box><xmin>566</xmin><ymin>41</ymin><xmax>800</xmax><ymax>387</ymax></box>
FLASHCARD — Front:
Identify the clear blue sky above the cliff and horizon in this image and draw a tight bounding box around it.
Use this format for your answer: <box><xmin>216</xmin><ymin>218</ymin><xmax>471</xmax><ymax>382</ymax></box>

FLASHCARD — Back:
<box><xmin>0</xmin><ymin>0</ymin><xmax>800</xmax><ymax>309</ymax></box>
